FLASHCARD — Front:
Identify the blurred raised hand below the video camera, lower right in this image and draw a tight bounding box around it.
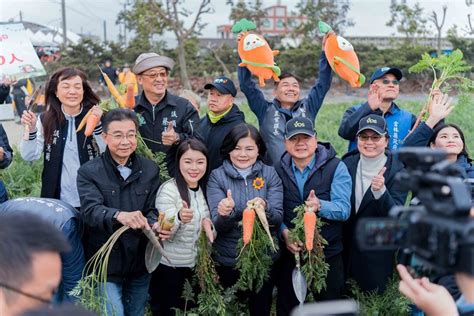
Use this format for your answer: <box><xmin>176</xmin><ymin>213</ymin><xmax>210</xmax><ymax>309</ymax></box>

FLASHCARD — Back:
<box><xmin>397</xmin><ymin>264</ymin><xmax>458</xmax><ymax>316</ymax></box>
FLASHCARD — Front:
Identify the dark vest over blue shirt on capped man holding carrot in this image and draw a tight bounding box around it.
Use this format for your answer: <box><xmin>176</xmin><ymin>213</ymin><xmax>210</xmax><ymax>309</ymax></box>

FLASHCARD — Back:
<box><xmin>276</xmin><ymin>149</ymin><xmax>342</xmax><ymax>258</ymax></box>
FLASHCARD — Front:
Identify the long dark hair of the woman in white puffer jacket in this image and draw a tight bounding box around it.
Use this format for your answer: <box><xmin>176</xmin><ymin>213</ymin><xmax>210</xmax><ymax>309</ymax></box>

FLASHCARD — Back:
<box><xmin>174</xmin><ymin>138</ymin><xmax>209</xmax><ymax>206</ymax></box>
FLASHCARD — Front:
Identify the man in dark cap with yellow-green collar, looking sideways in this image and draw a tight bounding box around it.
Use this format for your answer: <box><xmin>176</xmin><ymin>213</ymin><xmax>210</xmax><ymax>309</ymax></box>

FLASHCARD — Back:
<box><xmin>199</xmin><ymin>76</ymin><xmax>245</xmax><ymax>170</ymax></box>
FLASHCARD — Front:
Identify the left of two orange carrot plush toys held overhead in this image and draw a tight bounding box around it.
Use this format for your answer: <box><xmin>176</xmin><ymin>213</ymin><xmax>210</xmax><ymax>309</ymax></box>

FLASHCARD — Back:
<box><xmin>232</xmin><ymin>19</ymin><xmax>281</xmax><ymax>87</ymax></box>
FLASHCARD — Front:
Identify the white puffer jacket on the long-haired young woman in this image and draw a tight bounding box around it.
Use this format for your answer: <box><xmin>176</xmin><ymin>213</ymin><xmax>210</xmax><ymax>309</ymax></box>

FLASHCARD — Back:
<box><xmin>155</xmin><ymin>179</ymin><xmax>210</xmax><ymax>268</ymax></box>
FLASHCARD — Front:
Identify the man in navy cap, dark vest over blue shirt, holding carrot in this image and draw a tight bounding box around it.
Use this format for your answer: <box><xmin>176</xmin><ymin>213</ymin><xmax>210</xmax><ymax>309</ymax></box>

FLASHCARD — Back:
<box><xmin>275</xmin><ymin>117</ymin><xmax>352</xmax><ymax>315</ymax></box>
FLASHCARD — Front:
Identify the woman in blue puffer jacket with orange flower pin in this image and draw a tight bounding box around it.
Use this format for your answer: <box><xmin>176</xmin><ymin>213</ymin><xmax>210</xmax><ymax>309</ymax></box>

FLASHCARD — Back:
<box><xmin>207</xmin><ymin>124</ymin><xmax>283</xmax><ymax>315</ymax></box>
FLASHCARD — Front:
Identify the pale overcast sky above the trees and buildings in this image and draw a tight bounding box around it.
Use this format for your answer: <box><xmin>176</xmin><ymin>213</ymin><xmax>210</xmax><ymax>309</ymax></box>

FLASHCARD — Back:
<box><xmin>0</xmin><ymin>0</ymin><xmax>474</xmax><ymax>40</ymax></box>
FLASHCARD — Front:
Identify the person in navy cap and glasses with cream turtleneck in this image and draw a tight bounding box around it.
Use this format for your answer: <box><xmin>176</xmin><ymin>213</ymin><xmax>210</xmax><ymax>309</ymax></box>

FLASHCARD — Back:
<box><xmin>342</xmin><ymin>114</ymin><xmax>407</xmax><ymax>294</ymax></box>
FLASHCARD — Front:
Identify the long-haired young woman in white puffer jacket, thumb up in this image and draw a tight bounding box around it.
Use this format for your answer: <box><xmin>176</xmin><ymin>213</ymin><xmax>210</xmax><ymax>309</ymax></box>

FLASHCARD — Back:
<box><xmin>150</xmin><ymin>138</ymin><xmax>213</xmax><ymax>315</ymax></box>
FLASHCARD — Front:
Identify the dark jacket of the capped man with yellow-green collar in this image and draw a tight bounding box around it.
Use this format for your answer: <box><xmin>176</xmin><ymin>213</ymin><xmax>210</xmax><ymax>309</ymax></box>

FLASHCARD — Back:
<box><xmin>199</xmin><ymin>104</ymin><xmax>245</xmax><ymax>170</ymax></box>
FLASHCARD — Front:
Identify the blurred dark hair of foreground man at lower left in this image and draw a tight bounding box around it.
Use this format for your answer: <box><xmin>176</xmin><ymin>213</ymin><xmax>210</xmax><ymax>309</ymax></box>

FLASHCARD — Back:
<box><xmin>0</xmin><ymin>212</ymin><xmax>70</xmax><ymax>303</ymax></box>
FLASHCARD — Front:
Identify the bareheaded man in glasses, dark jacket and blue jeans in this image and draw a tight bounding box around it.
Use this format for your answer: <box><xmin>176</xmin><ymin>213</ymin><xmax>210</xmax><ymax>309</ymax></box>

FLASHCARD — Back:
<box><xmin>77</xmin><ymin>109</ymin><xmax>160</xmax><ymax>315</ymax></box>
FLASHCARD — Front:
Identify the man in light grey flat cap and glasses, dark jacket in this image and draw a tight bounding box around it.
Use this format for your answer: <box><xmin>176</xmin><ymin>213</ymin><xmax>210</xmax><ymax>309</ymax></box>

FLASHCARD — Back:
<box><xmin>132</xmin><ymin>53</ymin><xmax>199</xmax><ymax>176</ymax></box>
